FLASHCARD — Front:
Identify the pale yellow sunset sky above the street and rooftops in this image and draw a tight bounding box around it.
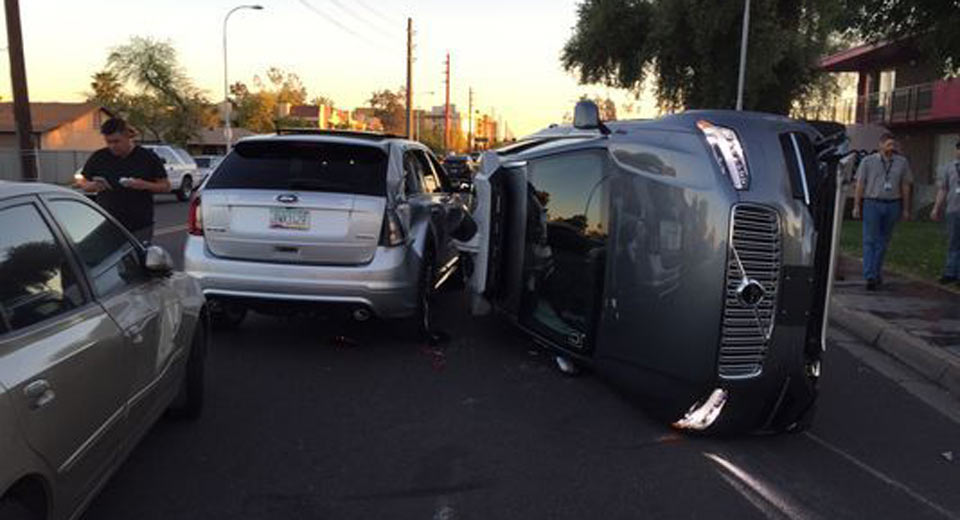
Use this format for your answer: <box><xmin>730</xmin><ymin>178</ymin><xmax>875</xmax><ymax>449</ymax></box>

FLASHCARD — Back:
<box><xmin>0</xmin><ymin>0</ymin><xmax>653</xmax><ymax>136</ymax></box>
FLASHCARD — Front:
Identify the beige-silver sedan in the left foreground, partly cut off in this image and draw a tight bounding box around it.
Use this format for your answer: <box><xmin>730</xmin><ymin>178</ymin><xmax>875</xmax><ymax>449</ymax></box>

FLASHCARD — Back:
<box><xmin>0</xmin><ymin>182</ymin><xmax>208</xmax><ymax>520</ymax></box>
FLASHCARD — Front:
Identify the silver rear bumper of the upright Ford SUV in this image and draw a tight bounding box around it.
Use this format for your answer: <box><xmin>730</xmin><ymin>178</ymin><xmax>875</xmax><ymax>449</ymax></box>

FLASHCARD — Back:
<box><xmin>184</xmin><ymin>236</ymin><xmax>419</xmax><ymax>318</ymax></box>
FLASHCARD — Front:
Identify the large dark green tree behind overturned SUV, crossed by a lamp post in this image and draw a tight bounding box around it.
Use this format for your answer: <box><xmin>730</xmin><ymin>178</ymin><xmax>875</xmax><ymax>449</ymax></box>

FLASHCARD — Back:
<box><xmin>561</xmin><ymin>0</ymin><xmax>842</xmax><ymax>114</ymax></box>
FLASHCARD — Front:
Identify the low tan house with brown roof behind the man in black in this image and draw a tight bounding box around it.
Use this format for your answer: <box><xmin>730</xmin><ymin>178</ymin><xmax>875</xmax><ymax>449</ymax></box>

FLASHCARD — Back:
<box><xmin>0</xmin><ymin>103</ymin><xmax>111</xmax><ymax>151</ymax></box>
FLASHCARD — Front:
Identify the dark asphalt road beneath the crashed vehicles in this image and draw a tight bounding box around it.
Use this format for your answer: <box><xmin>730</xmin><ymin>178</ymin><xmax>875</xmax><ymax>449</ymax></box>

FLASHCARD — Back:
<box><xmin>84</xmin><ymin>200</ymin><xmax>960</xmax><ymax>520</ymax></box>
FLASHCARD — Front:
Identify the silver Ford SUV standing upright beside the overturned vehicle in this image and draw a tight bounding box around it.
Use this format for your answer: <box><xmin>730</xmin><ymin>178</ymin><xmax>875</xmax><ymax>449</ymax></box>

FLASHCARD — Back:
<box><xmin>184</xmin><ymin>131</ymin><xmax>472</xmax><ymax>334</ymax></box>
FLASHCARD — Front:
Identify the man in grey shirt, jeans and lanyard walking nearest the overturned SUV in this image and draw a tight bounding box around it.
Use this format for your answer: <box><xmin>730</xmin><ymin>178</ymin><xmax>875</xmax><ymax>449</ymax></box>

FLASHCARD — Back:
<box><xmin>853</xmin><ymin>133</ymin><xmax>913</xmax><ymax>291</ymax></box>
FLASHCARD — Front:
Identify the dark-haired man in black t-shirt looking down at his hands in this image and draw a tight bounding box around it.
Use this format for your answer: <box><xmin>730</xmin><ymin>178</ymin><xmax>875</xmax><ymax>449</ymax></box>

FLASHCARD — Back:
<box><xmin>78</xmin><ymin>118</ymin><xmax>170</xmax><ymax>242</ymax></box>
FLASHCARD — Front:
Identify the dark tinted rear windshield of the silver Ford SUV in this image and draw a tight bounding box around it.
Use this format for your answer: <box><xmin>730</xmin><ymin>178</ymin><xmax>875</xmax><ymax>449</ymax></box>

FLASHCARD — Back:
<box><xmin>205</xmin><ymin>141</ymin><xmax>387</xmax><ymax>196</ymax></box>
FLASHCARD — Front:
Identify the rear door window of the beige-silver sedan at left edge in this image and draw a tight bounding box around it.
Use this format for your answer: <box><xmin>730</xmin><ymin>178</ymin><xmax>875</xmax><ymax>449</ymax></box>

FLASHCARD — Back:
<box><xmin>0</xmin><ymin>204</ymin><xmax>84</xmax><ymax>334</ymax></box>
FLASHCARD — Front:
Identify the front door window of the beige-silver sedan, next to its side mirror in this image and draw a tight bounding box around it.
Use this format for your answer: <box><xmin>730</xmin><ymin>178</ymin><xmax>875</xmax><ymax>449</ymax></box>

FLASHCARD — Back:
<box><xmin>49</xmin><ymin>200</ymin><xmax>148</xmax><ymax>298</ymax></box>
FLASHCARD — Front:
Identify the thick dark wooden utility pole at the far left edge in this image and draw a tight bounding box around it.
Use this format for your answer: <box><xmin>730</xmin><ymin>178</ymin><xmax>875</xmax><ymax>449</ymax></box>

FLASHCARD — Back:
<box><xmin>4</xmin><ymin>0</ymin><xmax>39</xmax><ymax>182</ymax></box>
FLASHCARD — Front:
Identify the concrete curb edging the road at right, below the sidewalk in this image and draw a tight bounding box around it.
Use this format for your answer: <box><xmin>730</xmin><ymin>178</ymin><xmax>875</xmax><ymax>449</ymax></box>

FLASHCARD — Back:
<box><xmin>830</xmin><ymin>298</ymin><xmax>960</xmax><ymax>399</ymax></box>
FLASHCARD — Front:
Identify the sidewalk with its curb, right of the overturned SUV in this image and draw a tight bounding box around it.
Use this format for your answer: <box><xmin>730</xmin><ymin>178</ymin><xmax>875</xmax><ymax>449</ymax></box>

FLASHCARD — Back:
<box><xmin>830</xmin><ymin>256</ymin><xmax>960</xmax><ymax>398</ymax></box>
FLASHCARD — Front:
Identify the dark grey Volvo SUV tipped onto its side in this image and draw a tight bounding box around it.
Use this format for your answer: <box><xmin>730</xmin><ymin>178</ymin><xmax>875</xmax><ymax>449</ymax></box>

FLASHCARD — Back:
<box><xmin>460</xmin><ymin>102</ymin><xmax>846</xmax><ymax>433</ymax></box>
